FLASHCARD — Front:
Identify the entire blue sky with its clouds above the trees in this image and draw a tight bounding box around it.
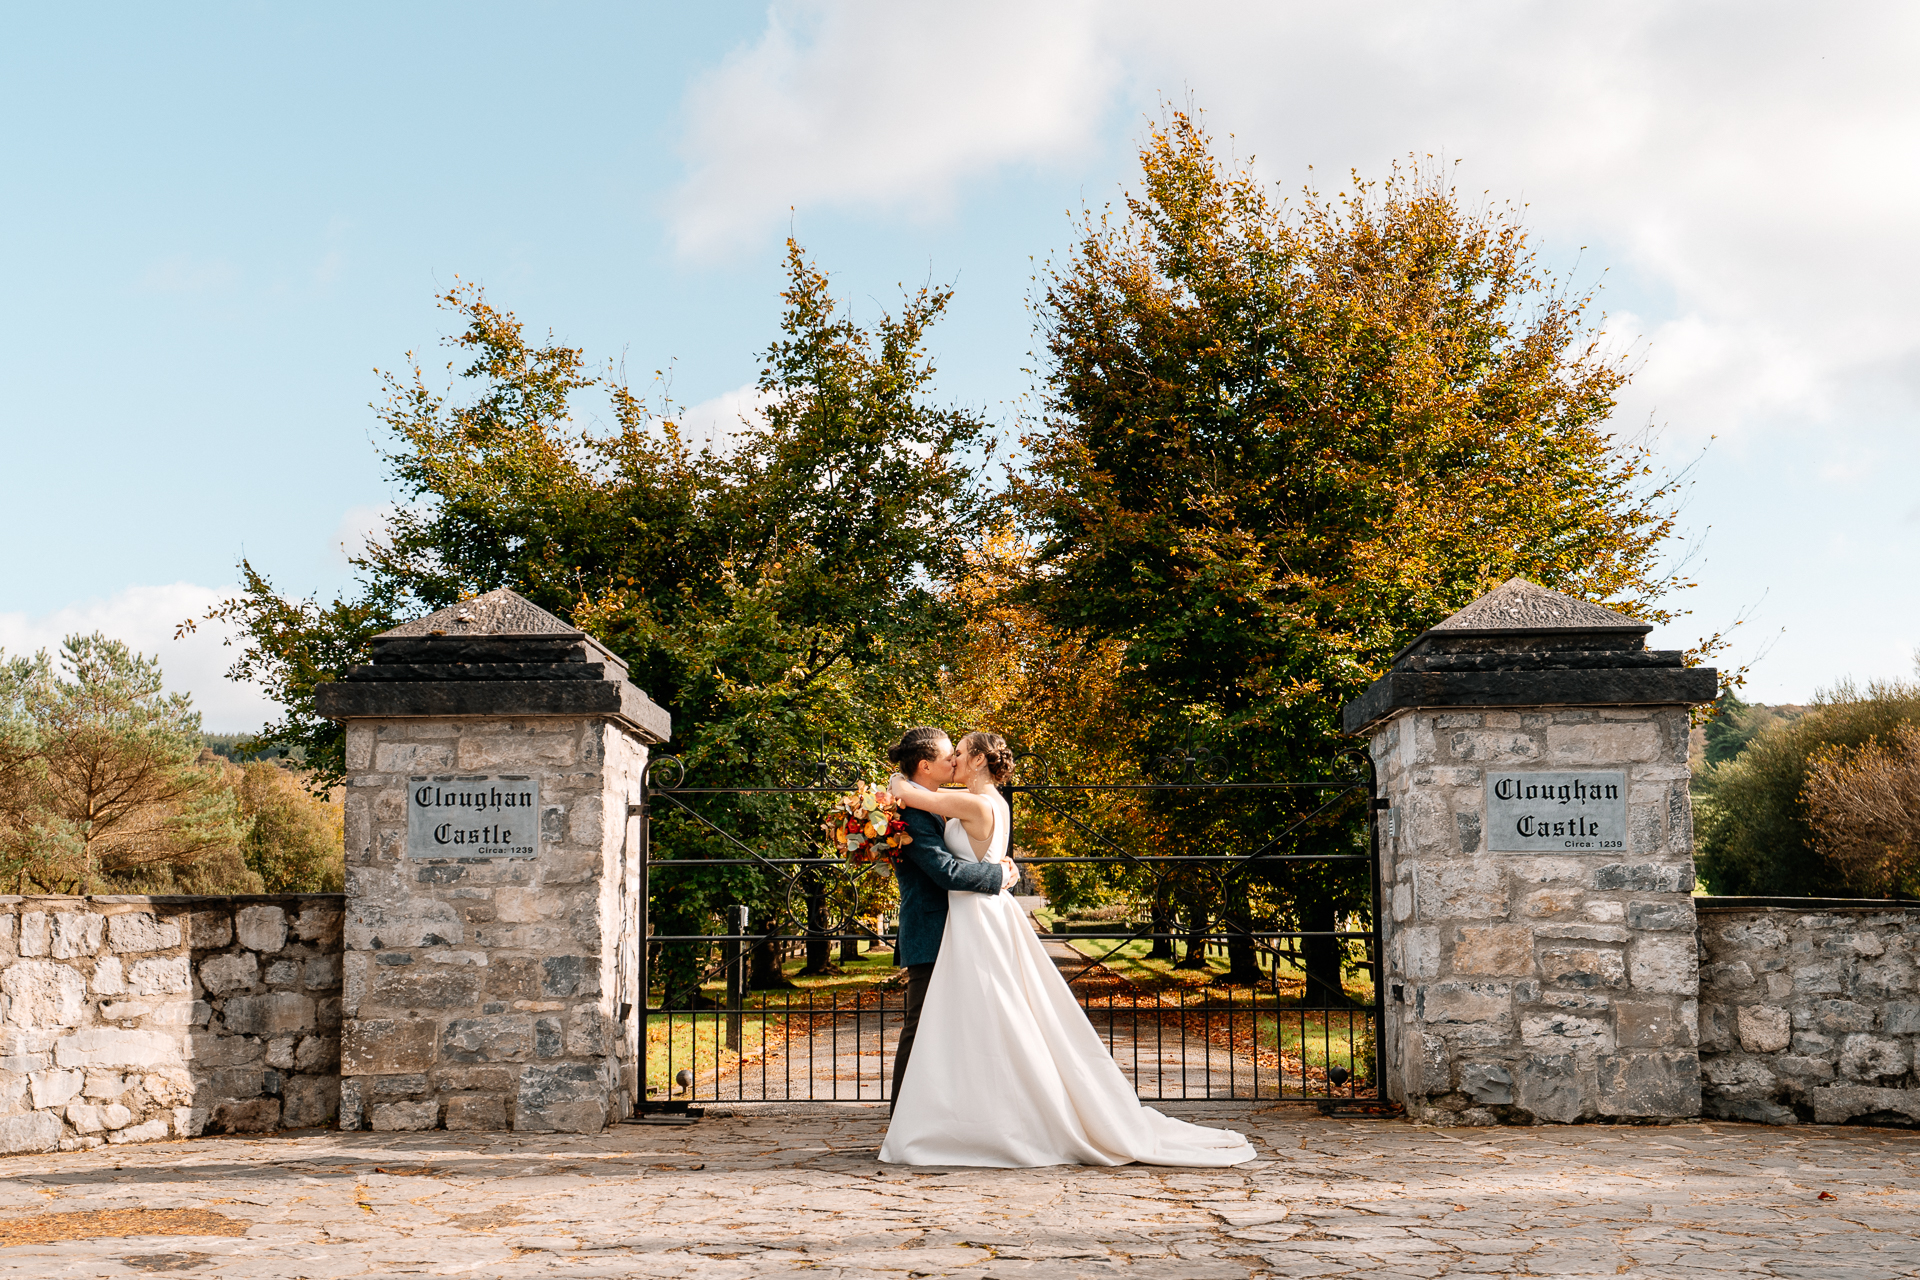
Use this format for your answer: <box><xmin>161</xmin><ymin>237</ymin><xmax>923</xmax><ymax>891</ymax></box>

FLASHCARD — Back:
<box><xmin>0</xmin><ymin>0</ymin><xmax>1920</xmax><ymax>729</ymax></box>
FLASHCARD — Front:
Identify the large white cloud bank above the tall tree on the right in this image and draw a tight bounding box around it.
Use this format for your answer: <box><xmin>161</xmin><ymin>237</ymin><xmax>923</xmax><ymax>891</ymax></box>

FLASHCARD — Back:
<box><xmin>674</xmin><ymin>0</ymin><xmax>1920</xmax><ymax>443</ymax></box>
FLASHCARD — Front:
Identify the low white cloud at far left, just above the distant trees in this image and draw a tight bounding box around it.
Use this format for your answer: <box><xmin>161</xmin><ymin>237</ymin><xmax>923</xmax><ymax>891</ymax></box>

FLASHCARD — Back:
<box><xmin>0</xmin><ymin>581</ymin><xmax>278</xmax><ymax>733</ymax></box>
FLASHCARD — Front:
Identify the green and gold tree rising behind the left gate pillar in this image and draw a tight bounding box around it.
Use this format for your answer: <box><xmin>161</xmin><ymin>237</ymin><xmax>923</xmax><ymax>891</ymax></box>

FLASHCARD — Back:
<box><xmin>206</xmin><ymin>242</ymin><xmax>983</xmax><ymax>984</ymax></box>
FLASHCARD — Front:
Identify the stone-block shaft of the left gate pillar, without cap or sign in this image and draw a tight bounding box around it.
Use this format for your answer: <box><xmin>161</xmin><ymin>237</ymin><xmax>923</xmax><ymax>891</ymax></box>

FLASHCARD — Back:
<box><xmin>340</xmin><ymin>716</ymin><xmax>647</xmax><ymax>1132</ymax></box>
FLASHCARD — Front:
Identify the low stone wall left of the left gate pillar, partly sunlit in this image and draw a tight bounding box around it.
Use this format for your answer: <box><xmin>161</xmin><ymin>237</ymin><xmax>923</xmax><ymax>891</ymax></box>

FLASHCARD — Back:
<box><xmin>0</xmin><ymin>894</ymin><xmax>342</xmax><ymax>1153</ymax></box>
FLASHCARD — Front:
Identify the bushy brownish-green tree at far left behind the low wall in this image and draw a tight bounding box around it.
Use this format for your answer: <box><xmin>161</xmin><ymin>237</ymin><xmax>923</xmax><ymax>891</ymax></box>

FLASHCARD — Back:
<box><xmin>0</xmin><ymin>631</ymin><xmax>257</xmax><ymax>892</ymax></box>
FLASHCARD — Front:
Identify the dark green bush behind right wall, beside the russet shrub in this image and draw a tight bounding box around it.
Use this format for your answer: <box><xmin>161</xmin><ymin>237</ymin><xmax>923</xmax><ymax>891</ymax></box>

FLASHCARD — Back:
<box><xmin>1693</xmin><ymin>681</ymin><xmax>1920</xmax><ymax>898</ymax></box>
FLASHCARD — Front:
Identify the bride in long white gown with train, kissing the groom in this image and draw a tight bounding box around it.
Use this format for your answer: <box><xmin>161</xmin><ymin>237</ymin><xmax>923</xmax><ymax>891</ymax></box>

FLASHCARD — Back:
<box><xmin>879</xmin><ymin>733</ymin><xmax>1254</xmax><ymax>1169</ymax></box>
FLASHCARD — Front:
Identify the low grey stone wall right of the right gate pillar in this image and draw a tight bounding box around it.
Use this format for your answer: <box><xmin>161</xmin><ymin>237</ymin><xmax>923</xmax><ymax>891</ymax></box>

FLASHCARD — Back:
<box><xmin>1699</xmin><ymin>898</ymin><xmax>1920</xmax><ymax>1125</ymax></box>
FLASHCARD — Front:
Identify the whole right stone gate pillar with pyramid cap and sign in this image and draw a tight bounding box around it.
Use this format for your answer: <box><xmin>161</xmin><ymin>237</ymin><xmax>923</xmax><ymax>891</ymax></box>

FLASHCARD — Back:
<box><xmin>1344</xmin><ymin>578</ymin><xmax>1716</xmax><ymax>1125</ymax></box>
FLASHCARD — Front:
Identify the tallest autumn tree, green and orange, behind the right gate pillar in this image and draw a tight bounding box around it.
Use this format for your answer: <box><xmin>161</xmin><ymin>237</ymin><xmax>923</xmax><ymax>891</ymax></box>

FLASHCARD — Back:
<box><xmin>1014</xmin><ymin>113</ymin><xmax>1704</xmax><ymax>984</ymax></box>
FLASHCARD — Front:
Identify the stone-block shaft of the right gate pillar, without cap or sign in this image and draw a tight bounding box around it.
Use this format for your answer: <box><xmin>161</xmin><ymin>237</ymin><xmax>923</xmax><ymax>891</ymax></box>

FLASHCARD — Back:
<box><xmin>1371</xmin><ymin>706</ymin><xmax>1699</xmax><ymax>1125</ymax></box>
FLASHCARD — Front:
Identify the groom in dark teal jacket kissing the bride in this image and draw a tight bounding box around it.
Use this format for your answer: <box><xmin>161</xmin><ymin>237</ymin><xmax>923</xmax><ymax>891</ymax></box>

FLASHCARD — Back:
<box><xmin>893</xmin><ymin>725</ymin><xmax>1020</xmax><ymax>1102</ymax></box>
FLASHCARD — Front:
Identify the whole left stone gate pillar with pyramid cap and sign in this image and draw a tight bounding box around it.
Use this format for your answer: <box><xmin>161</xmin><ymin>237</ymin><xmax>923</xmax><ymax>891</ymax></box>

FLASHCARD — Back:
<box><xmin>317</xmin><ymin>589</ymin><xmax>672</xmax><ymax>1132</ymax></box>
